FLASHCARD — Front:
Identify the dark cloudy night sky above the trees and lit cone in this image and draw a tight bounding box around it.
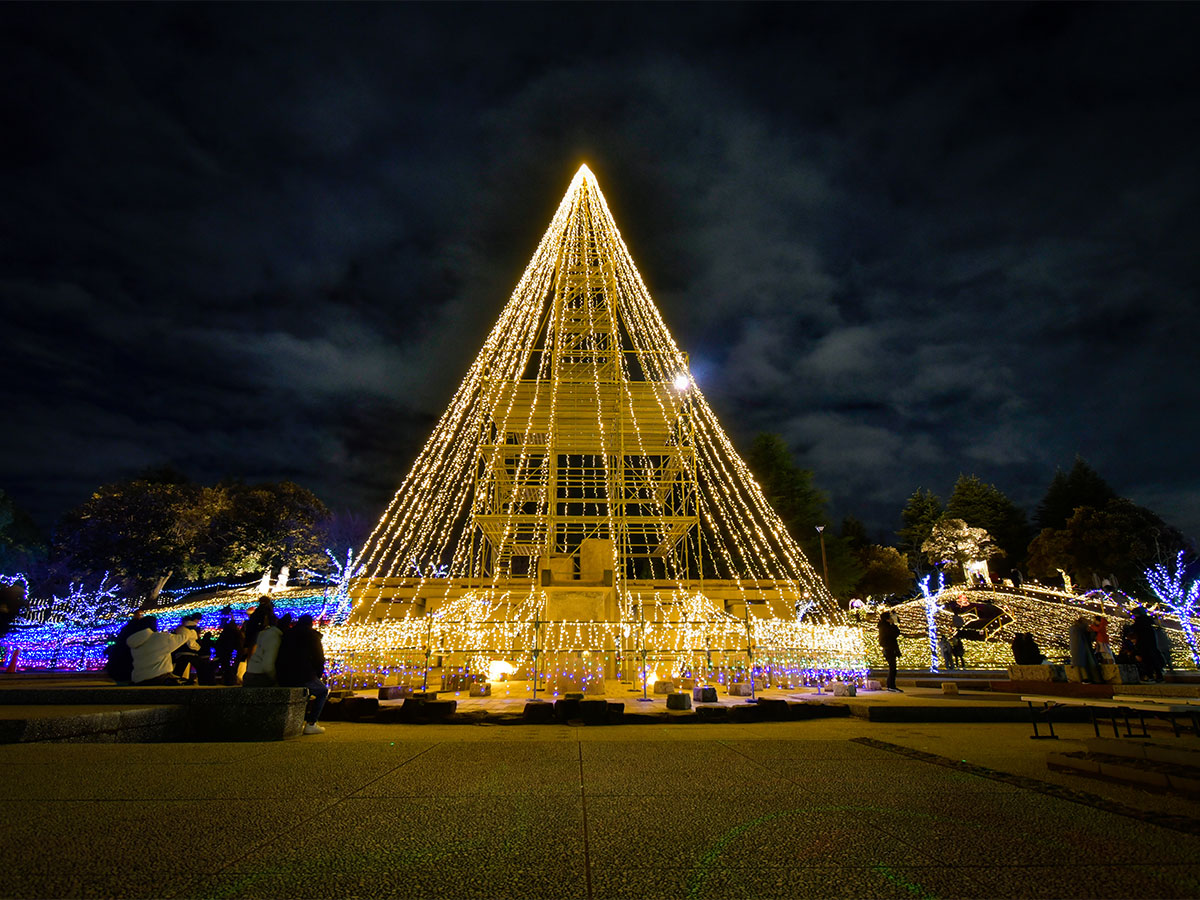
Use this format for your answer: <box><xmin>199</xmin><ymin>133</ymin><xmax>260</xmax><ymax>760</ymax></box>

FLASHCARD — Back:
<box><xmin>0</xmin><ymin>4</ymin><xmax>1200</xmax><ymax>547</ymax></box>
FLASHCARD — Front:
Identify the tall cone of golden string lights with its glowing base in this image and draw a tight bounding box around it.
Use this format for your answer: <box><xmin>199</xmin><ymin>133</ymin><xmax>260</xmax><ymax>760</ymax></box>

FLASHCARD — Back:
<box><xmin>326</xmin><ymin>166</ymin><xmax>863</xmax><ymax>692</ymax></box>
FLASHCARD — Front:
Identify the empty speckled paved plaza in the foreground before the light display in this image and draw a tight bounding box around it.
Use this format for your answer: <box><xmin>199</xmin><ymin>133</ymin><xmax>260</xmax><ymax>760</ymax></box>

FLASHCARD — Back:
<box><xmin>0</xmin><ymin>719</ymin><xmax>1200</xmax><ymax>900</ymax></box>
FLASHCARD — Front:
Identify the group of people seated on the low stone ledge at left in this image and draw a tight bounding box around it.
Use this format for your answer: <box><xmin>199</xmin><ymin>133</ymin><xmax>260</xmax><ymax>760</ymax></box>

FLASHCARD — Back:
<box><xmin>106</xmin><ymin>596</ymin><xmax>329</xmax><ymax>734</ymax></box>
